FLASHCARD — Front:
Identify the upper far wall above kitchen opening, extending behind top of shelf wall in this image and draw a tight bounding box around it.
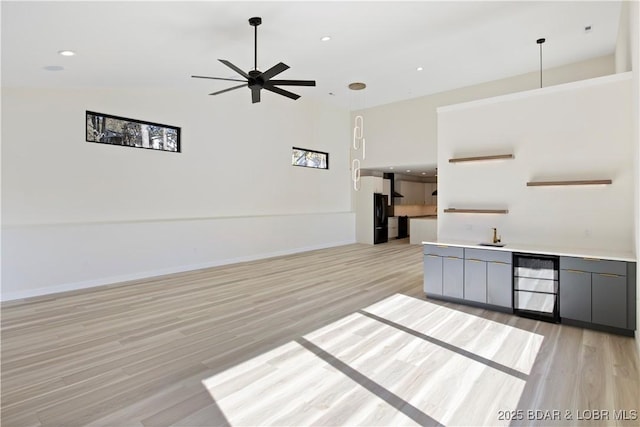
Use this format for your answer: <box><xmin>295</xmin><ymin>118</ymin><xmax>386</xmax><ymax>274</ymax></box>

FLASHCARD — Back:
<box><xmin>353</xmin><ymin>55</ymin><xmax>615</xmax><ymax>168</ymax></box>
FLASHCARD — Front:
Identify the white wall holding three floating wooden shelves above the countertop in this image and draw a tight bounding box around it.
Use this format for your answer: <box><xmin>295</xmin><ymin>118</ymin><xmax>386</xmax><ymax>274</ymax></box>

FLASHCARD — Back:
<box><xmin>438</xmin><ymin>73</ymin><xmax>636</xmax><ymax>253</ymax></box>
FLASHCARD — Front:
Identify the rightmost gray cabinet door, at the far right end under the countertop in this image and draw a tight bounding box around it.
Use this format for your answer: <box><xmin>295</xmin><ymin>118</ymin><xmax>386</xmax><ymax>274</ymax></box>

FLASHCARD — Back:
<box><xmin>591</xmin><ymin>273</ymin><xmax>624</xmax><ymax>328</ymax></box>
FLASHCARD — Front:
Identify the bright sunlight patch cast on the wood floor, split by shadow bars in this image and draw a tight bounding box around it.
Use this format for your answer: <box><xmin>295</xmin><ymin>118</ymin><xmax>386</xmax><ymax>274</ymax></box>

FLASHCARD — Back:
<box><xmin>203</xmin><ymin>294</ymin><xmax>543</xmax><ymax>426</ymax></box>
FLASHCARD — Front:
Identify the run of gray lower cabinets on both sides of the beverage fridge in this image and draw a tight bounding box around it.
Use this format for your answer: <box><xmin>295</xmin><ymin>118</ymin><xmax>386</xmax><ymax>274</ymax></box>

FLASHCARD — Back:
<box><xmin>423</xmin><ymin>244</ymin><xmax>636</xmax><ymax>335</ymax></box>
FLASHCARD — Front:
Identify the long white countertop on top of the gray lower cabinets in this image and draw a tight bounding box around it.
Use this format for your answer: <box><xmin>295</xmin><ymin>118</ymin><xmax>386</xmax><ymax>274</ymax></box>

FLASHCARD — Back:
<box><xmin>422</xmin><ymin>240</ymin><xmax>636</xmax><ymax>262</ymax></box>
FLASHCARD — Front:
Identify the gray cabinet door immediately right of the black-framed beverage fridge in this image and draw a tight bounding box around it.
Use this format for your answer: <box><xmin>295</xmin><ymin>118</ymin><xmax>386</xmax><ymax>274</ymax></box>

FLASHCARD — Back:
<box><xmin>559</xmin><ymin>270</ymin><xmax>591</xmax><ymax>322</ymax></box>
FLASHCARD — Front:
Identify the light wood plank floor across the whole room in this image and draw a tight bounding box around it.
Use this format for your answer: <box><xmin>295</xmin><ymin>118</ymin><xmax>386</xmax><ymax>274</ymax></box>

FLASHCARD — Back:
<box><xmin>1</xmin><ymin>241</ymin><xmax>640</xmax><ymax>427</ymax></box>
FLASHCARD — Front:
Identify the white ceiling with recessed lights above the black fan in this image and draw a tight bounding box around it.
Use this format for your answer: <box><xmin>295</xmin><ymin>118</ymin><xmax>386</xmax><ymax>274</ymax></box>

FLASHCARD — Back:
<box><xmin>2</xmin><ymin>1</ymin><xmax>620</xmax><ymax>109</ymax></box>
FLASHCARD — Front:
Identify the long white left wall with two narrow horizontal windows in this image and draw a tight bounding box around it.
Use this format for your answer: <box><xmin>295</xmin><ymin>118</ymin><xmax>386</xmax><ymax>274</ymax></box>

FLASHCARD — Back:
<box><xmin>2</xmin><ymin>88</ymin><xmax>355</xmax><ymax>299</ymax></box>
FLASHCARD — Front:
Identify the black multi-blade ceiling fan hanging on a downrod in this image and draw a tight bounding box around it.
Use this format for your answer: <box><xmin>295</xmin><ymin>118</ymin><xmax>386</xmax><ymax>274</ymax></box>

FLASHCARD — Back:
<box><xmin>191</xmin><ymin>17</ymin><xmax>316</xmax><ymax>104</ymax></box>
